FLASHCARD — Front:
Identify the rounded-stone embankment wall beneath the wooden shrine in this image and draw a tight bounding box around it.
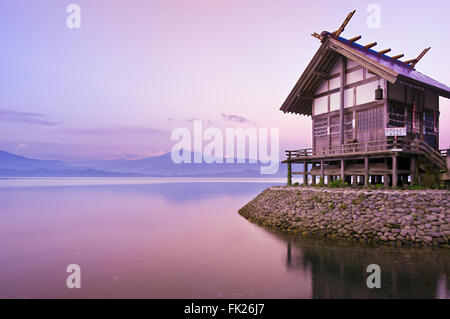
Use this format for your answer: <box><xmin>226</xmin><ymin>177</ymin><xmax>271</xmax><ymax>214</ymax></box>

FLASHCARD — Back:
<box><xmin>239</xmin><ymin>187</ymin><xmax>450</xmax><ymax>247</ymax></box>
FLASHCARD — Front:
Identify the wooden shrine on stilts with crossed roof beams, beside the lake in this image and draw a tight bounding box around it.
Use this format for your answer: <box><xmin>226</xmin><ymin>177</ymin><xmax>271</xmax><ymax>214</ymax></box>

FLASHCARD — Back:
<box><xmin>281</xmin><ymin>11</ymin><xmax>450</xmax><ymax>186</ymax></box>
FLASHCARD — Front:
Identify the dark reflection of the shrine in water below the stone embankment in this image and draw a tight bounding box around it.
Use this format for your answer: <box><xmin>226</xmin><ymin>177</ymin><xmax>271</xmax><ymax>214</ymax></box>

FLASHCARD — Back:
<box><xmin>280</xmin><ymin>235</ymin><xmax>450</xmax><ymax>298</ymax></box>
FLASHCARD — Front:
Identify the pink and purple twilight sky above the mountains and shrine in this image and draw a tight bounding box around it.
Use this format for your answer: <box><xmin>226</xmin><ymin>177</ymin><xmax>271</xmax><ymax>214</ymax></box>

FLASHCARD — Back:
<box><xmin>0</xmin><ymin>0</ymin><xmax>450</xmax><ymax>161</ymax></box>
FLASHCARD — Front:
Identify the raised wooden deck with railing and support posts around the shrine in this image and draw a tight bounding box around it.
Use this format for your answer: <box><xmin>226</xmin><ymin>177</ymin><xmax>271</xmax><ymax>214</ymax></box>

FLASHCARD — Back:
<box><xmin>283</xmin><ymin>138</ymin><xmax>448</xmax><ymax>186</ymax></box>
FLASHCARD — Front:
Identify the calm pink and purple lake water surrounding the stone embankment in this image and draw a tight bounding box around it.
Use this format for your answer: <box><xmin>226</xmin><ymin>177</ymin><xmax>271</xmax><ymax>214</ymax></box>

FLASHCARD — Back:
<box><xmin>0</xmin><ymin>179</ymin><xmax>450</xmax><ymax>298</ymax></box>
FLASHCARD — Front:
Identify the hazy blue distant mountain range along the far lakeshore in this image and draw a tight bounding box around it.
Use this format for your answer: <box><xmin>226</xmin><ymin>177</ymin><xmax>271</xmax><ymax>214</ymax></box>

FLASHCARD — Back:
<box><xmin>0</xmin><ymin>151</ymin><xmax>286</xmax><ymax>178</ymax></box>
